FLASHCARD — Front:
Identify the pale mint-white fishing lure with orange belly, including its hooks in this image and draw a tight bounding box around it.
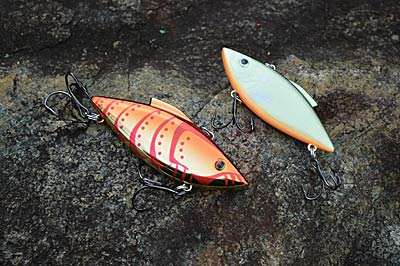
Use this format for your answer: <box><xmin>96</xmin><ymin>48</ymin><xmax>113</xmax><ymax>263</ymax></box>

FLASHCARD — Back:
<box><xmin>213</xmin><ymin>48</ymin><xmax>342</xmax><ymax>200</ymax></box>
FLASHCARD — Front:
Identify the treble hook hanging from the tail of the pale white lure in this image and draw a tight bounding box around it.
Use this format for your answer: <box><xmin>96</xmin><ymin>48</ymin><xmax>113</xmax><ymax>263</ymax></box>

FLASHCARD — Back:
<box><xmin>302</xmin><ymin>144</ymin><xmax>343</xmax><ymax>200</ymax></box>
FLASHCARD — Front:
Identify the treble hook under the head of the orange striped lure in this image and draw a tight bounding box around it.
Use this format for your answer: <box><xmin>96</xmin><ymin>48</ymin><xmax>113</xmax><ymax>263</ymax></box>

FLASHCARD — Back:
<box><xmin>131</xmin><ymin>165</ymin><xmax>192</xmax><ymax>212</ymax></box>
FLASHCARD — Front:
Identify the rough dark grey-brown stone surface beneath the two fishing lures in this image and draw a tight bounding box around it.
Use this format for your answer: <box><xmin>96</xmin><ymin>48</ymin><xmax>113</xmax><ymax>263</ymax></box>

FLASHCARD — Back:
<box><xmin>0</xmin><ymin>0</ymin><xmax>400</xmax><ymax>265</ymax></box>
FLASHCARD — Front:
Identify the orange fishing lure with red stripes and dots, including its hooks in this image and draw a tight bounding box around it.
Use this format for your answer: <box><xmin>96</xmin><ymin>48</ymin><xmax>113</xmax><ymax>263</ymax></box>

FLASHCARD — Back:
<box><xmin>44</xmin><ymin>72</ymin><xmax>248</xmax><ymax>210</ymax></box>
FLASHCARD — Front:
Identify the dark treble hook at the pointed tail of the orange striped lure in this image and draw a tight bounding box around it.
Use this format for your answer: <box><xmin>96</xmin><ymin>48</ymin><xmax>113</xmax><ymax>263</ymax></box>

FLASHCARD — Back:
<box><xmin>44</xmin><ymin>71</ymin><xmax>103</xmax><ymax>123</ymax></box>
